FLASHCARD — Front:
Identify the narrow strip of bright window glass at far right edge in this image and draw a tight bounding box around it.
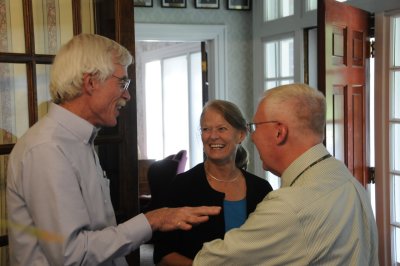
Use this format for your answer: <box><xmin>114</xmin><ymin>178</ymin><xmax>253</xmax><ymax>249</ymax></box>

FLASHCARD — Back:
<box><xmin>389</xmin><ymin>16</ymin><xmax>400</xmax><ymax>264</ymax></box>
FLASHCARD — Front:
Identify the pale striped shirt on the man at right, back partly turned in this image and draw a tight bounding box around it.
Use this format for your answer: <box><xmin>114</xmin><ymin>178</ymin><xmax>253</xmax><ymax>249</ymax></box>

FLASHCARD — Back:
<box><xmin>193</xmin><ymin>144</ymin><xmax>379</xmax><ymax>266</ymax></box>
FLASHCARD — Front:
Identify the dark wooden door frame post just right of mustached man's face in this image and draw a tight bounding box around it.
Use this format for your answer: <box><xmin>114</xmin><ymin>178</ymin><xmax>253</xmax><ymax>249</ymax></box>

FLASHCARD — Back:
<box><xmin>107</xmin><ymin>0</ymin><xmax>140</xmax><ymax>265</ymax></box>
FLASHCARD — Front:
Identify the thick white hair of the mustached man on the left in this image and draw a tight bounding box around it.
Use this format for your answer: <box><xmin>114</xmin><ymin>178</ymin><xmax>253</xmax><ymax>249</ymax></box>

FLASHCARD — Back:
<box><xmin>50</xmin><ymin>34</ymin><xmax>133</xmax><ymax>104</ymax></box>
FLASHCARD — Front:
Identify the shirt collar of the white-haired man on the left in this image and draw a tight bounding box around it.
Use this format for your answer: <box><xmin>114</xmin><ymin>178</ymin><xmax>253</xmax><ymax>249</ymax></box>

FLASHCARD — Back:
<box><xmin>48</xmin><ymin>103</ymin><xmax>100</xmax><ymax>144</ymax></box>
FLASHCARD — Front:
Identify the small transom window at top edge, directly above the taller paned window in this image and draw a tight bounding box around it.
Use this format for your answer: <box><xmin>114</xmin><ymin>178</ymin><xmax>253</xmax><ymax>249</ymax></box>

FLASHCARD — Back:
<box><xmin>264</xmin><ymin>0</ymin><xmax>294</xmax><ymax>21</ymax></box>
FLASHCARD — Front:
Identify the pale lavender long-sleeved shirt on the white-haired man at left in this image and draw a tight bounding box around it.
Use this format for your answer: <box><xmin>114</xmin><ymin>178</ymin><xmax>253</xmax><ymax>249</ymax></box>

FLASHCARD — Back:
<box><xmin>7</xmin><ymin>104</ymin><xmax>152</xmax><ymax>265</ymax></box>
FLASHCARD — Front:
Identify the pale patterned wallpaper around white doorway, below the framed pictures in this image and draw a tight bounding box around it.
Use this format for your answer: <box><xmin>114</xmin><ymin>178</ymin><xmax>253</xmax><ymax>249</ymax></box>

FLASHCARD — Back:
<box><xmin>134</xmin><ymin>0</ymin><xmax>253</xmax><ymax>169</ymax></box>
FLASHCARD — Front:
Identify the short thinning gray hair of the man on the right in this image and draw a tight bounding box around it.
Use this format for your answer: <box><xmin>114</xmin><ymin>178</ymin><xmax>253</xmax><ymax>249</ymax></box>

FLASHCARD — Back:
<box><xmin>264</xmin><ymin>83</ymin><xmax>326</xmax><ymax>138</ymax></box>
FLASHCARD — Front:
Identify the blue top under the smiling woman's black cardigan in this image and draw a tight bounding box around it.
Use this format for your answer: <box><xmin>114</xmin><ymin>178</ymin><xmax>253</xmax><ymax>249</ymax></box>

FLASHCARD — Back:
<box><xmin>224</xmin><ymin>198</ymin><xmax>247</xmax><ymax>232</ymax></box>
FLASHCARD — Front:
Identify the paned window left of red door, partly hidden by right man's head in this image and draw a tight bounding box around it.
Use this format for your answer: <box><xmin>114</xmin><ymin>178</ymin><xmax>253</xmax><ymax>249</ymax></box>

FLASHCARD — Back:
<box><xmin>264</xmin><ymin>37</ymin><xmax>294</xmax><ymax>189</ymax></box>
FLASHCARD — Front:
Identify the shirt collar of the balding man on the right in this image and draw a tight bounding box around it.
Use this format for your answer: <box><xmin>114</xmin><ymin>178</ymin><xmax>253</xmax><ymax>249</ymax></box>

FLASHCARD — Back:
<box><xmin>281</xmin><ymin>144</ymin><xmax>329</xmax><ymax>187</ymax></box>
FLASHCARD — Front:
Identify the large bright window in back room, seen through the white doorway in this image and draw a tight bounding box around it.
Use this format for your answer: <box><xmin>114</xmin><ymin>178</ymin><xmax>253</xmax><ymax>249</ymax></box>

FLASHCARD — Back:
<box><xmin>138</xmin><ymin>43</ymin><xmax>203</xmax><ymax>169</ymax></box>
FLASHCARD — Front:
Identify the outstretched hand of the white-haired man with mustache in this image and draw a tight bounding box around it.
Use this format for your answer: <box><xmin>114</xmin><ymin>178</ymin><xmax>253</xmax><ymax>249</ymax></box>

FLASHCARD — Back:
<box><xmin>145</xmin><ymin>206</ymin><xmax>221</xmax><ymax>231</ymax></box>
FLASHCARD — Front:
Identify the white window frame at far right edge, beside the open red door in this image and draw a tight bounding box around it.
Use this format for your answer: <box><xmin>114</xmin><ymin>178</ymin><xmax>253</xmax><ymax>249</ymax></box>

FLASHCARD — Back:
<box><xmin>375</xmin><ymin>10</ymin><xmax>400</xmax><ymax>265</ymax></box>
